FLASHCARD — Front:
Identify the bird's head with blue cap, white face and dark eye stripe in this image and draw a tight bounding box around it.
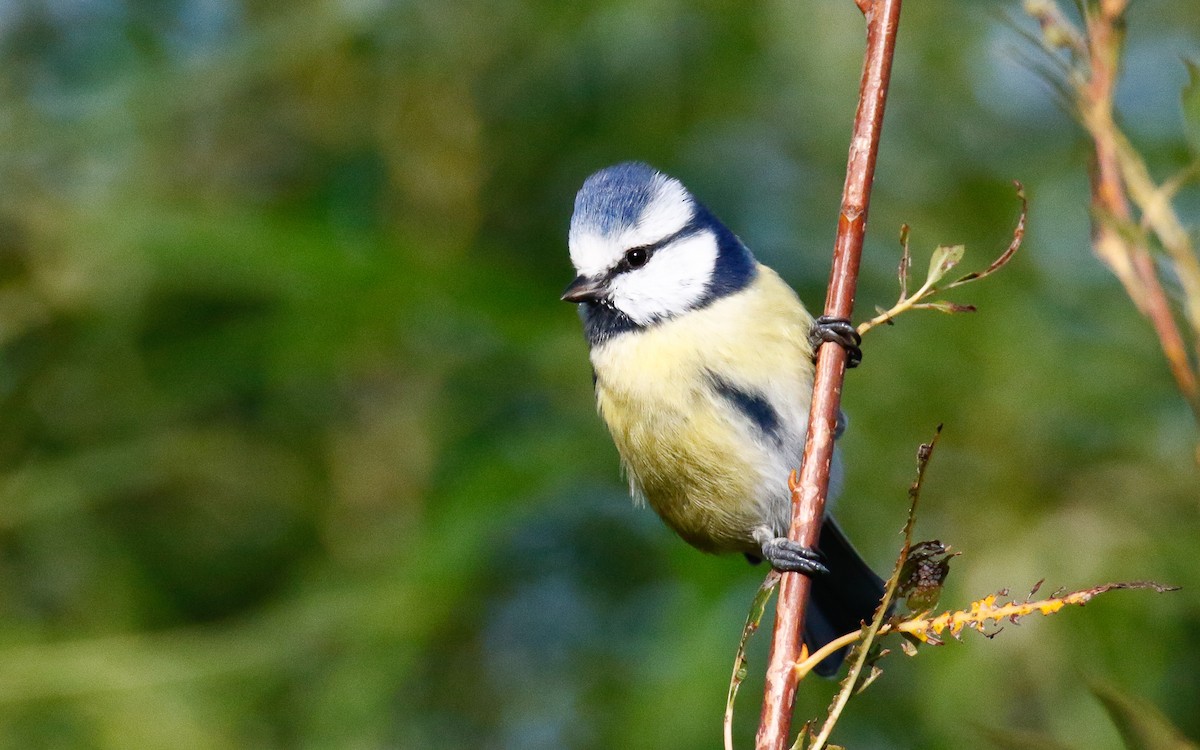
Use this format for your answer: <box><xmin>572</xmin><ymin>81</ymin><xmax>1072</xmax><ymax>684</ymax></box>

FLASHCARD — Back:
<box><xmin>563</xmin><ymin>162</ymin><xmax>755</xmax><ymax>343</ymax></box>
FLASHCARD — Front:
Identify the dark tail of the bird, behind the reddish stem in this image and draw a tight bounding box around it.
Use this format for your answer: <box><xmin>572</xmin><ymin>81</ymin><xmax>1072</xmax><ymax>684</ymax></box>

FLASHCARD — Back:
<box><xmin>804</xmin><ymin>515</ymin><xmax>883</xmax><ymax>677</ymax></box>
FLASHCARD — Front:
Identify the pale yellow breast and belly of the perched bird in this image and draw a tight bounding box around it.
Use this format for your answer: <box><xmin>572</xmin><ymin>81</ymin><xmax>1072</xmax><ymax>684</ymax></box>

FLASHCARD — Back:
<box><xmin>592</xmin><ymin>266</ymin><xmax>812</xmax><ymax>552</ymax></box>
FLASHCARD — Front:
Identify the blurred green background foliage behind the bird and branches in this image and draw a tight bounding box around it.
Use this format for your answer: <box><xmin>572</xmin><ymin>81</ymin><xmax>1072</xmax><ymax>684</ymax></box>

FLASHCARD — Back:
<box><xmin>0</xmin><ymin>0</ymin><xmax>1200</xmax><ymax>749</ymax></box>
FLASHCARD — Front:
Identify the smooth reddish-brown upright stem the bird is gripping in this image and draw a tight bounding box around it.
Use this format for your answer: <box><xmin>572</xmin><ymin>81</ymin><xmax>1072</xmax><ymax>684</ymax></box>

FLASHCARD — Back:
<box><xmin>756</xmin><ymin>0</ymin><xmax>900</xmax><ymax>750</ymax></box>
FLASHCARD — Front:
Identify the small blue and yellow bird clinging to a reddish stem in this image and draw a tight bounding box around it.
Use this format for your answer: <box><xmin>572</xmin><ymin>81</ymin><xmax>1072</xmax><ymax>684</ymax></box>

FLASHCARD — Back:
<box><xmin>562</xmin><ymin>162</ymin><xmax>883</xmax><ymax>676</ymax></box>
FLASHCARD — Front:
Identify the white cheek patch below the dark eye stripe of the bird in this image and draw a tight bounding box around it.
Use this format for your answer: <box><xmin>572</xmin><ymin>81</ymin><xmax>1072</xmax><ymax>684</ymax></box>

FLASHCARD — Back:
<box><xmin>612</xmin><ymin>232</ymin><xmax>718</xmax><ymax>325</ymax></box>
